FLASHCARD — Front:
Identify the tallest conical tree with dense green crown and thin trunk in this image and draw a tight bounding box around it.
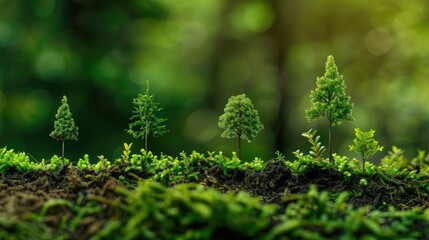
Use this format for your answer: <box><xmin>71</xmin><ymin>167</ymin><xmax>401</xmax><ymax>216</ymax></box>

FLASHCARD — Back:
<box><xmin>305</xmin><ymin>55</ymin><xmax>353</xmax><ymax>163</ymax></box>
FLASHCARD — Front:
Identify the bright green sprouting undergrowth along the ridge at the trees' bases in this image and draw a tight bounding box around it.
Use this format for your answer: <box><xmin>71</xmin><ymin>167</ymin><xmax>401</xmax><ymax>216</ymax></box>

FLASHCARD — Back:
<box><xmin>0</xmin><ymin>144</ymin><xmax>429</xmax><ymax>186</ymax></box>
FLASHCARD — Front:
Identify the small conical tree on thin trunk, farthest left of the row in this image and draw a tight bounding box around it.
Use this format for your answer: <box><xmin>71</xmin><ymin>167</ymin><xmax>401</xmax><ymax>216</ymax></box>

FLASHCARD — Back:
<box><xmin>49</xmin><ymin>96</ymin><xmax>78</xmax><ymax>166</ymax></box>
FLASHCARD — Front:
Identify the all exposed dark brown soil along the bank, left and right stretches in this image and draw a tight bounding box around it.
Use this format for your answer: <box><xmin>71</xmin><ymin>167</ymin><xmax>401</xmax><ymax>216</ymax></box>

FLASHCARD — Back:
<box><xmin>0</xmin><ymin>160</ymin><xmax>429</xmax><ymax>239</ymax></box>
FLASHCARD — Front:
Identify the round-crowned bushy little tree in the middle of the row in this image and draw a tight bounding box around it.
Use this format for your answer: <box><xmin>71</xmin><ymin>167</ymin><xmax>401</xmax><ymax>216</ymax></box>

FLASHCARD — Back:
<box><xmin>219</xmin><ymin>94</ymin><xmax>264</xmax><ymax>159</ymax></box>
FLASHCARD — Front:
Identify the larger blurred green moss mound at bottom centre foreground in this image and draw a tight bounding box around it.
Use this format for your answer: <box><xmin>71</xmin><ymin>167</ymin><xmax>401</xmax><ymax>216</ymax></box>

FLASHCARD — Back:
<box><xmin>94</xmin><ymin>181</ymin><xmax>277</xmax><ymax>239</ymax></box>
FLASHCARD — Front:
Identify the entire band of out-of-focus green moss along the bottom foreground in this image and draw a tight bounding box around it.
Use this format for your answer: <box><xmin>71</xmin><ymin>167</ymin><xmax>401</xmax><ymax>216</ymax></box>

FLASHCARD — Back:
<box><xmin>31</xmin><ymin>180</ymin><xmax>429</xmax><ymax>240</ymax></box>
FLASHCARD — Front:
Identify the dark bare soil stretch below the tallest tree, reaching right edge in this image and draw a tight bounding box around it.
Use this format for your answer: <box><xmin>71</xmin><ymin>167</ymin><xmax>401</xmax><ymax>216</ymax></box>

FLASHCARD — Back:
<box><xmin>201</xmin><ymin>160</ymin><xmax>429</xmax><ymax>210</ymax></box>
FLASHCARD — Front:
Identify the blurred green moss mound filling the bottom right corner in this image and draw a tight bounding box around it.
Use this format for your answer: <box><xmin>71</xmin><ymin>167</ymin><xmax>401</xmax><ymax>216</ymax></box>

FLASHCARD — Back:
<box><xmin>265</xmin><ymin>187</ymin><xmax>429</xmax><ymax>239</ymax></box>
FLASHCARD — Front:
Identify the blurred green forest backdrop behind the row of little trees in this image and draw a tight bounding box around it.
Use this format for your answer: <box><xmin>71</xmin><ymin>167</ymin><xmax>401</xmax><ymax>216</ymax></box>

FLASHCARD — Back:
<box><xmin>0</xmin><ymin>0</ymin><xmax>429</xmax><ymax>161</ymax></box>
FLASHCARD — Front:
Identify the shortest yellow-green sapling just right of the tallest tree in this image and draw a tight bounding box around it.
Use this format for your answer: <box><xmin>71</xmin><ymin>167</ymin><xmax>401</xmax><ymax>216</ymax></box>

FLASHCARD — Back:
<box><xmin>349</xmin><ymin>128</ymin><xmax>383</xmax><ymax>172</ymax></box>
